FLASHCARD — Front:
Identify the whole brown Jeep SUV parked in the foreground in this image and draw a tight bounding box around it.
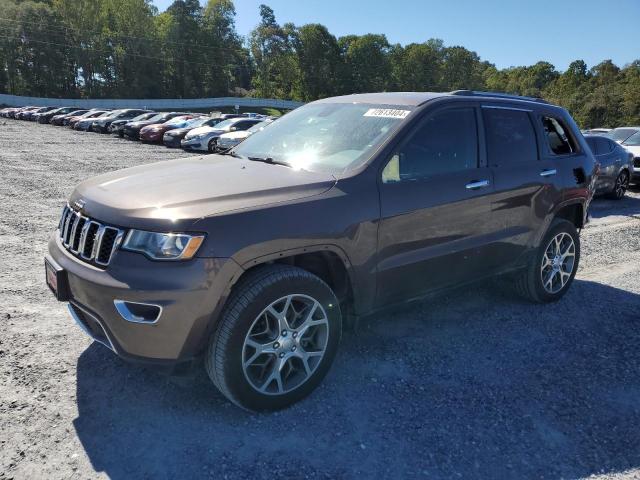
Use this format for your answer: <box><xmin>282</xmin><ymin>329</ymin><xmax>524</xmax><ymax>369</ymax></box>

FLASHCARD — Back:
<box><xmin>46</xmin><ymin>91</ymin><xmax>595</xmax><ymax>410</ymax></box>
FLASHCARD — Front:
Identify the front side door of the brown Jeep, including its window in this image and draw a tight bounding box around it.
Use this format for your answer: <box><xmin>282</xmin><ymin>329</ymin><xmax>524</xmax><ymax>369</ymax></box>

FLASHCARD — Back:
<box><xmin>376</xmin><ymin>103</ymin><xmax>493</xmax><ymax>305</ymax></box>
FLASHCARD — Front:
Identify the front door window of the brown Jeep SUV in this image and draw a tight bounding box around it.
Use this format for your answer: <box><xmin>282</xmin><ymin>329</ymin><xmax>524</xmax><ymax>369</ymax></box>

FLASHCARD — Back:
<box><xmin>382</xmin><ymin>108</ymin><xmax>478</xmax><ymax>183</ymax></box>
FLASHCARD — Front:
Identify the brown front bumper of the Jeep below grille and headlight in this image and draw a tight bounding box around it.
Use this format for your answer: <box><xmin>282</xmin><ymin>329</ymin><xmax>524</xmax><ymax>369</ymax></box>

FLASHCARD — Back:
<box><xmin>47</xmin><ymin>232</ymin><xmax>241</xmax><ymax>364</ymax></box>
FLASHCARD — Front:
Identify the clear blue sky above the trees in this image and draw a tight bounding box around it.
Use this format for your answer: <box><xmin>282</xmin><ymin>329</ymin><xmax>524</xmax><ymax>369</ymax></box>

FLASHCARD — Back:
<box><xmin>154</xmin><ymin>0</ymin><xmax>640</xmax><ymax>70</ymax></box>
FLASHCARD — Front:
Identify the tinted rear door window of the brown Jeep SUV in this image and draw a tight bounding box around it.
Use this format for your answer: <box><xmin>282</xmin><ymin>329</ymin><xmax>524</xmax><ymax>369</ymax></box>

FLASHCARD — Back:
<box><xmin>482</xmin><ymin>107</ymin><xmax>538</xmax><ymax>167</ymax></box>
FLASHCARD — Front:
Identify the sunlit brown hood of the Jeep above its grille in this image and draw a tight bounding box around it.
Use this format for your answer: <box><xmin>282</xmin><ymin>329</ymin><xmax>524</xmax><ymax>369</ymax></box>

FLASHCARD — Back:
<box><xmin>69</xmin><ymin>155</ymin><xmax>336</xmax><ymax>230</ymax></box>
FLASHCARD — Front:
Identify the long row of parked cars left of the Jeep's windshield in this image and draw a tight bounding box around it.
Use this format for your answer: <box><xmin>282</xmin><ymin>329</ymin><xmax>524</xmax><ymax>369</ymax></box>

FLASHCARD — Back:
<box><xmin>0</xmin><ymin>106</ymin><xmax>274</xmax><ymax>152</ymax></box>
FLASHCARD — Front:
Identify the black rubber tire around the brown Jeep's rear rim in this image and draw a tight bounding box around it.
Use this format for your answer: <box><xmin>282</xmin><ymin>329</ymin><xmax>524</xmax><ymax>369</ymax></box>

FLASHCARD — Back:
<box><xmin>515</xmin><ymin>218</ymin><xmax>580</xmax><ymax>303</ymax></box>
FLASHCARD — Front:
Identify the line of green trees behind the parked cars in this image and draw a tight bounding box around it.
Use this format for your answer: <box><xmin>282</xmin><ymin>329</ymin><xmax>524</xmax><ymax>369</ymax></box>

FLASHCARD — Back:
<box><xmin>0</xmin><ymin>0</ymin><xmax>640</xmax><ymax>128</ymax></box>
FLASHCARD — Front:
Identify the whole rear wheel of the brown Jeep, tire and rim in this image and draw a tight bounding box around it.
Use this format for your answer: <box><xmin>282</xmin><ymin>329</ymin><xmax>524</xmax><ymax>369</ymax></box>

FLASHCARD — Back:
<box><xmin>515</xmin><ymin>219</ymin><xmax>580</xmax><ymax>303</ymax></box>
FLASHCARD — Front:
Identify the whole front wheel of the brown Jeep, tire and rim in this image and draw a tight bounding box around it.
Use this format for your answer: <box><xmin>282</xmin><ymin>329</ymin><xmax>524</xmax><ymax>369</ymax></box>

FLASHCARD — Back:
<box><xmin>205</xmin><ymin>265</ymin><xmax>342</xmax><ymax>411</ymax></box>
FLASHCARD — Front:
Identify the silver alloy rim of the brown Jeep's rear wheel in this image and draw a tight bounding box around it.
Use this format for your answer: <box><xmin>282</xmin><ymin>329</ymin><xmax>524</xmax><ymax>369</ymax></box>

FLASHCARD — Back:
<box><xmin>540</xmin><ymin>232</ymin><xmax>576</xmax><ymax>294</ymax></box>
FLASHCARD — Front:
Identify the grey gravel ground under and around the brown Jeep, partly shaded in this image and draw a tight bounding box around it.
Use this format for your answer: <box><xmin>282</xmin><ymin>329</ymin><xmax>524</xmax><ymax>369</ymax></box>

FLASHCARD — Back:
<box><xmin>0</xmin><ymin>121</ymin><xmax>640</xmax><ymax>480</ymax></box>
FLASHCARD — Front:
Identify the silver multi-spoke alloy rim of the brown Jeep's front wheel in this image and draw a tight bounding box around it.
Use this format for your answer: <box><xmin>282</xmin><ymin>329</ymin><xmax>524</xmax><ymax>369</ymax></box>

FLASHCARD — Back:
<box><xmin>242</xmin><ymin>294</ymin><xmax>329</xmax><ymax>395</ymax></box>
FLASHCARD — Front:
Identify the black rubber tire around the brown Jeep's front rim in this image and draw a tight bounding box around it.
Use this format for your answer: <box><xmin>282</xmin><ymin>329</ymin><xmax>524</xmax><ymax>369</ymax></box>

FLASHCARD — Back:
<box><xmin>205</xmin><ymin>265</ymin><xmax>342</xmax><ymax>411</ymax></box>
